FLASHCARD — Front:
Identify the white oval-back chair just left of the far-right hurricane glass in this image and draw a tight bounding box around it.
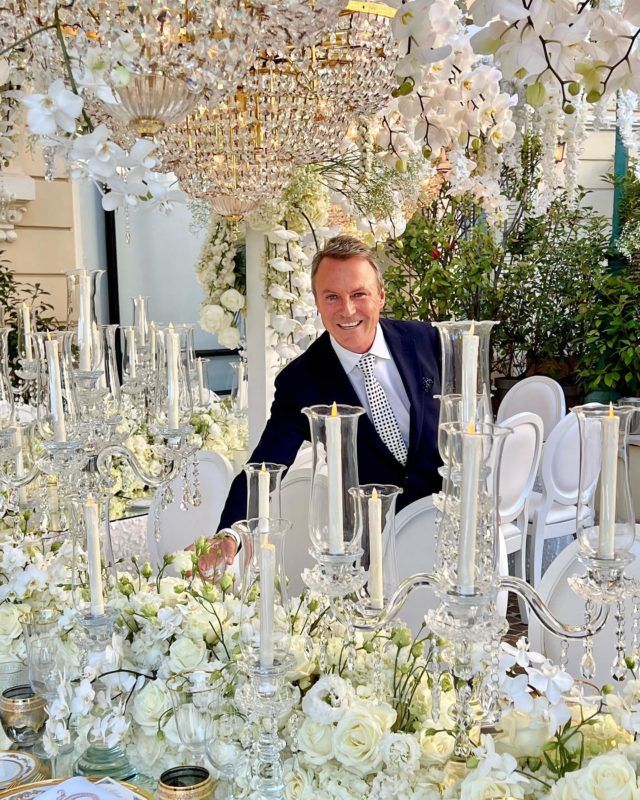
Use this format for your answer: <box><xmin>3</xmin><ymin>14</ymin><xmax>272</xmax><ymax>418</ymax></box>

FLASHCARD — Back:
<box><xmin>523</xmin><ymin>414</ymin><xmax>591</xmax><ymax>587</ymax></box>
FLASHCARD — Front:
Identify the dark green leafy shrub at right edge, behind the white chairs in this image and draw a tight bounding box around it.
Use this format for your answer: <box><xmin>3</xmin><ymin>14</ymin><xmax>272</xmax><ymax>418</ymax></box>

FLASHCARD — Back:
<box><xmin>578</xmin><ymin>269</ymin><xmax>640</xmax><ymax>397</ymax></box>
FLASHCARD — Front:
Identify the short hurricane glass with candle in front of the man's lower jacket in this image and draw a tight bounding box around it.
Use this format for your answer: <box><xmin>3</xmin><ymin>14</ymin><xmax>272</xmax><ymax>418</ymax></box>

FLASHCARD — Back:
<box><xmin>349</xmin><ymin>483</ymin><xmax>402</xmax><ymax>611</ymax></box>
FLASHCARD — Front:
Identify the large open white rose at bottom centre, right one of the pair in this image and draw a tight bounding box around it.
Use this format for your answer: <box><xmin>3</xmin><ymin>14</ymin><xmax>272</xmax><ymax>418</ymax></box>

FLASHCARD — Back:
<box><xmin>333</xmin><ymin>703</ymin><xmax>383</xmax><ymax>775</ymax></box>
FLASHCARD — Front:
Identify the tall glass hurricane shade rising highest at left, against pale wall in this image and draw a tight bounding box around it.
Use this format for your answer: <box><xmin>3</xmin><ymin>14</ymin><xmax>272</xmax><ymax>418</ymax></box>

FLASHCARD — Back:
<box><xmin>67</xmin><ymin>269</ymin><xmax>105</xmax><ymax>373</ymax></box>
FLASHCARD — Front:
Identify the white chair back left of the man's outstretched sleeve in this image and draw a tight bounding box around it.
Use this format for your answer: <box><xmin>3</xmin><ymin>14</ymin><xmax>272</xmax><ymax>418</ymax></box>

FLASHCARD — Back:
<box><xmin>147</xmin><ymin>450</ymin><xmax>233</xmax><ymax>565</ymax></box>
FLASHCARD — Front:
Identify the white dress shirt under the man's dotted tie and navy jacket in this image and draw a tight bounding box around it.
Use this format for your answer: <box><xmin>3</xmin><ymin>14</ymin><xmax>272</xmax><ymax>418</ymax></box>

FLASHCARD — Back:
<box><xmin>330</xmin><ymin>323</ymin><xmax>410</xmax><ymax>450</ymax></box>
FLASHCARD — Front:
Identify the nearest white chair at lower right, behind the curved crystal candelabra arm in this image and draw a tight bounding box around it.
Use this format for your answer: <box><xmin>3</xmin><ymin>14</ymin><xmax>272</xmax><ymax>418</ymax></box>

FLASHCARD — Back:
<box><xmin>528</xmin><ymin>536</ymin><xmax>640</xmax><ymax>686</ymax></box>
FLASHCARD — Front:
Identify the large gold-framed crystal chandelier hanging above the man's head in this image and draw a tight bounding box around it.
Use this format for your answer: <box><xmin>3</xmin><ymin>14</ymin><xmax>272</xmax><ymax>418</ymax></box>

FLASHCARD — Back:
<box><xmin>162</xmin><ymin>2</ymin><xmax>395</xmax><ymax>216</ymax></box>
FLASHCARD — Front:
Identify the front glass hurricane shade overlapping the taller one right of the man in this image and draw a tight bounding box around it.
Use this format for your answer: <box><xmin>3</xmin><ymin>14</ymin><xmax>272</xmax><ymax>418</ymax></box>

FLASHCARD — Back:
<box><xmin>436</xmin><ymin>422</ymin><xmax>512</xmax><ymax>597</ymax></box>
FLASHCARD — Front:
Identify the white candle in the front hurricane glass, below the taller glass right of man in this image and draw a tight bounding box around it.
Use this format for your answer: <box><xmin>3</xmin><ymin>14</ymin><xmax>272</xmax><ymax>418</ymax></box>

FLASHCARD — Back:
<box><xmin>458</xmin><ymin>421</ymin><xmax>482</xmax><ymax>595</ymax></box>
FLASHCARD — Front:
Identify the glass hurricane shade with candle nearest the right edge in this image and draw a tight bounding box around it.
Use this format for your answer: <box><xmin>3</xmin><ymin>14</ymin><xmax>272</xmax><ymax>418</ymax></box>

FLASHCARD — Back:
<box><xmin>572</xmin><ymin>404</ymin><xmax>636</xmax><ymax>569</ymax></box>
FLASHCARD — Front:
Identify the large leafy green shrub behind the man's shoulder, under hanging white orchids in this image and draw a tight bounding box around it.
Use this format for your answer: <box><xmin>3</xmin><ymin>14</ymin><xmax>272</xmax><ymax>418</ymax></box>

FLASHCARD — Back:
<box><xmin>385</xmin><ymin>145</ymin><xmax>608</xmax><ymax>377</ymax></box>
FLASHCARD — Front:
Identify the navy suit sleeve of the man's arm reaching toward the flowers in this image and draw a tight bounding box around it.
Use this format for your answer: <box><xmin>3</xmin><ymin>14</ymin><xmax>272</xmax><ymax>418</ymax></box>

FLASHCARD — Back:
<box><xmin>218</xmin><ymin>371</ymin><xmax>309</xmax><ymax>530</ymax></box>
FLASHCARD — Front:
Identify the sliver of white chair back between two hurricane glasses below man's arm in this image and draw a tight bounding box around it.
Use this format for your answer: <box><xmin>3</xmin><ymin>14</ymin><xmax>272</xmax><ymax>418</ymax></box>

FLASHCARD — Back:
<box><xmin>280</xmin><ymin>467</ymin><xmax>315</xmax><ymax>597</ymax></box>
